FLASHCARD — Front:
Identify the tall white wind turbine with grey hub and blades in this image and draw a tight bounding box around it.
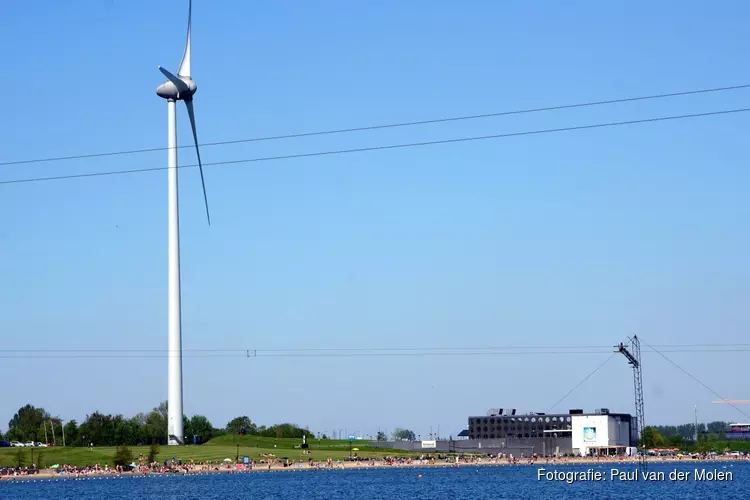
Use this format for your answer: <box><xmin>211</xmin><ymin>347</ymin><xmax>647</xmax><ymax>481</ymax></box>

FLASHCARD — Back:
<box><xmin>156</xmin><ymin>0</ymin><xmax>211</xmax><ymax>445</ymax></box>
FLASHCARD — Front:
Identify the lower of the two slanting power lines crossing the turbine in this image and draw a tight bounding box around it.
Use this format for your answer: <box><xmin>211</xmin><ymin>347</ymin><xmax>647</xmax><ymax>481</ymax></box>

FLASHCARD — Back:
<box><xmin>0</xmin><ymin>108</ymin><xmax>750</xmax><ymax>188</ymax></box>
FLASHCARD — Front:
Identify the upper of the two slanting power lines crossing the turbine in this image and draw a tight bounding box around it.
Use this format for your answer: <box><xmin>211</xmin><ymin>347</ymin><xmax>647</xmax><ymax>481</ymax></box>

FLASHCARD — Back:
<box><xmin>0</xmin><ymin>84</ymin><xmax>750</xmax><ymax>166</ymax></box>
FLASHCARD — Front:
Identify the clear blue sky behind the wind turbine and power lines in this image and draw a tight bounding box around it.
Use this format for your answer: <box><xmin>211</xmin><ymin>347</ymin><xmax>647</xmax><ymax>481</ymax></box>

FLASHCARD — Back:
<box><xmin>0</xmin><ymin>0</ymin><xmax>750</xmax><ymax>435</ymax></box>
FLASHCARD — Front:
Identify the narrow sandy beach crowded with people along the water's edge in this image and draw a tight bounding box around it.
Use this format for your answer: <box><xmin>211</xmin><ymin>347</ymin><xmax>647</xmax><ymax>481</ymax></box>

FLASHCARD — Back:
<box><xmin>0</xmin><ymin>457</ymin><xmax>750</xmax><ymax>483</ymax></box>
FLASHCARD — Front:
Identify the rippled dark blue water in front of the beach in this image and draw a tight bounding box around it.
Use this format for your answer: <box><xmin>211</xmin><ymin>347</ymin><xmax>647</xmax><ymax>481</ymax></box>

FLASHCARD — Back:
<box><xmin>0</xmin><ymin>462</ymin><xmax>750</xmax><ymax>500</ymax></box>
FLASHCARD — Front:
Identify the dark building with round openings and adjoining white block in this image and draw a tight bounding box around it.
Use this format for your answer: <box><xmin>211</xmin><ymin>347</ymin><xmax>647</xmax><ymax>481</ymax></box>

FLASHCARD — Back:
<box><xmin>468</xmin><ymin>408</ymin><xmax>638</xmax><ymax>456</ymax></box>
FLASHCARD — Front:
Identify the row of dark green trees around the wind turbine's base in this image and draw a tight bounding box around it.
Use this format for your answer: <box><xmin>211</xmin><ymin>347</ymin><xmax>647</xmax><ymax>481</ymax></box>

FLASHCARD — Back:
<box><xmin>0</xmin><ymin>402</ymin><xmax>312</xmax><ymax>446</ymax></box>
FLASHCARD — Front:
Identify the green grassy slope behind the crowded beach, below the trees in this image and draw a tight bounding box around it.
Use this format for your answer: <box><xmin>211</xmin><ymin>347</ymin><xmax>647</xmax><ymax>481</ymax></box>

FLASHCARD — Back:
<box><xmin>0</xmin><ymin>435</ymin><xmax>406</xmax><ymax>467</ymax></box>
